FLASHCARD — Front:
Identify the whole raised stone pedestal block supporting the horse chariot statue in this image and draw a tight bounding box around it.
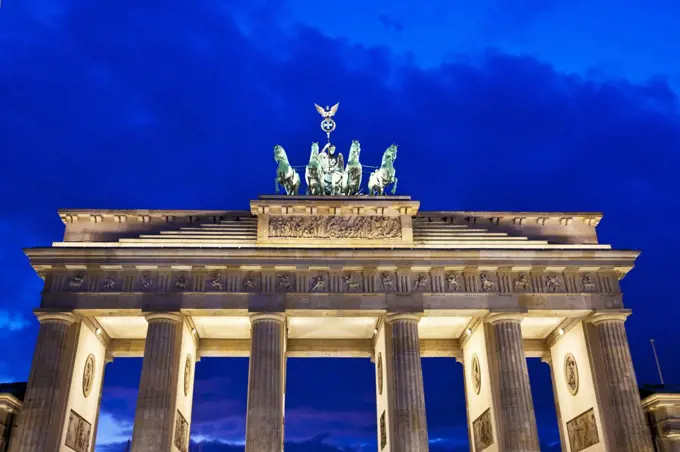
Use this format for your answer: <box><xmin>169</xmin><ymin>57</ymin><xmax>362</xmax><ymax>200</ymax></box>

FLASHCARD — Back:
<box><xmin>250</xmin><ymin>196</ymin><xmax>420</xmax><ymax>248</ymax></box>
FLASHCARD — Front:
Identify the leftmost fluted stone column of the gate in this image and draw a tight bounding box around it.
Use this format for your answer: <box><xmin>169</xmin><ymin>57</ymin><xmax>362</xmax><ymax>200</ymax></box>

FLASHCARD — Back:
<box><xmin>10</xmin><ymin>313</ymin><xmax>75</xmax><ymax>452</ymax></box>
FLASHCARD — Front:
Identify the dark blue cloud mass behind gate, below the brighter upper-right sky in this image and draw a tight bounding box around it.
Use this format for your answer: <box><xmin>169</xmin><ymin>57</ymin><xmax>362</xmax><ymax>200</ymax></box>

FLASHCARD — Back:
<box><xmin>0</xmin><ymin>0</ymin><xmax>680</xmax><ymax>450</ymax></box>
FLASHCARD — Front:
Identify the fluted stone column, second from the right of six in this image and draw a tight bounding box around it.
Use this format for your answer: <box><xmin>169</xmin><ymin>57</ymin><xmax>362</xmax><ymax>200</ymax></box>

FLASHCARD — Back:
<box><xmin>487</xmin><ymin>313</ymin><xmax>541</xmax><ymax>452</ymax></box>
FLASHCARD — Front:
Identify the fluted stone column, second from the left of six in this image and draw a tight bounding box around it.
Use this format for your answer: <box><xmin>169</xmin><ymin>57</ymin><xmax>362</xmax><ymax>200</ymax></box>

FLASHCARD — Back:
<box><xmin>132</xmin><ymin>313</ymin><xmax>182</xmax><ymax>452</ymax></box>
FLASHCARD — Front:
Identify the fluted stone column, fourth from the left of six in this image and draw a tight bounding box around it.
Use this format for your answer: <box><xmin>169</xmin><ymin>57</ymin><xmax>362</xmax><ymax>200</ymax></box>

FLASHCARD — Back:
<box><xmin>386</xmin><ymin>314</ymin><xmax>429</xmax><ymax>452</ymax></box>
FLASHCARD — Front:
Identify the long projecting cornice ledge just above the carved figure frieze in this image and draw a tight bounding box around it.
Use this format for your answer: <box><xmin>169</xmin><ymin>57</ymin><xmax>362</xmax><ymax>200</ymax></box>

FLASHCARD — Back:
<box><xmin>24</xmin><ymin>248</ymin><xmax>640</xmax><ymax>279</ymax></box>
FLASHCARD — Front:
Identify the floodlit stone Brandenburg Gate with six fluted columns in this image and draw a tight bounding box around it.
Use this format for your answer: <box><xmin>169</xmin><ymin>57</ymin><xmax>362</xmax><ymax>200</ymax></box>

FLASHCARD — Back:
<box><xmin>10</xmin><ymin>110</ymin><xmax>654</xmax><ymax>452</ymax></box>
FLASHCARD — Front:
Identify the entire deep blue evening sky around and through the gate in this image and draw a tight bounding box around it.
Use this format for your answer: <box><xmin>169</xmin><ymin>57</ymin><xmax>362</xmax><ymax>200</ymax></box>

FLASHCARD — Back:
<box><xmin>0</xmin><ymin>0</ymin><xmax>680</xmax><ymax>452</ymax></box>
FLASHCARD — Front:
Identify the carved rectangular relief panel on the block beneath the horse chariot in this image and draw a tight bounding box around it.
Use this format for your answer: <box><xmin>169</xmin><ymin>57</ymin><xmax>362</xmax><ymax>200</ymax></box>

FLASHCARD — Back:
<box><xmin>269</xmin><ymin>216</ymin><xmax>401</xmax><ymax>240</ymax></box>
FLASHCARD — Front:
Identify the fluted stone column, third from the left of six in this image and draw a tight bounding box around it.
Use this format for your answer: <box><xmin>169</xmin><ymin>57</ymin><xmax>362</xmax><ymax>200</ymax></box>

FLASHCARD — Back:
<box><xmin>246</xmin><ymin>313</ymin><xmax>286</xmax><ymax>452</ymax></box>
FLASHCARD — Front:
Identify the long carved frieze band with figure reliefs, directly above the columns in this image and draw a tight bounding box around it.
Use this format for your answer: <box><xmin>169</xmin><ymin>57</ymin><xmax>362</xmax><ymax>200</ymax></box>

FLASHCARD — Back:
<box><xmin>46</xmin><ymin>269</ymin><xmax>620</xmax><ymax>295</ymax></box>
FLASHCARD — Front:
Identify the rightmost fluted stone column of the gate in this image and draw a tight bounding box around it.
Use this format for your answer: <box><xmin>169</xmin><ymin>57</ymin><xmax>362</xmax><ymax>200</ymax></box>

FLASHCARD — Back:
<box><xmin>590</xmin><ymin>312</ymin><xmax>654</xmax><ymax>452</ymax></box>
